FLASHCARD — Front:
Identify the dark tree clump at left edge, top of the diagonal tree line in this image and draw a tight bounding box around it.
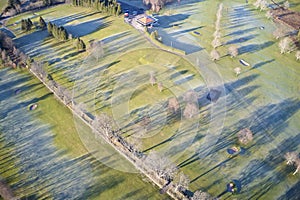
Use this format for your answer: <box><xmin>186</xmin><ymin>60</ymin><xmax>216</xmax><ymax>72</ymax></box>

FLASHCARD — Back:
<box><xmin>0</xmin><ymin>31</ymin><xmax>27</xmax><ymax>68</ymax></box>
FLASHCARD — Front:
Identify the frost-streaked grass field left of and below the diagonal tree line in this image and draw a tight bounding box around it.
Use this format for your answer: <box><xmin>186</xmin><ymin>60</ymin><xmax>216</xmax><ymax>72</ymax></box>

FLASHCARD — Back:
<box><xmin>0</xmin><ymin>68</ymin><xmax>167</xmax><ymax>199</ymax></box>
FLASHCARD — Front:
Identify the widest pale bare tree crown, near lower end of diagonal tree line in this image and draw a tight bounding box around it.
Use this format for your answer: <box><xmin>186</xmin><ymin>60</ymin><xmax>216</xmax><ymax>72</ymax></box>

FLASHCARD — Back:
<box><xmin>144</xmin><ymin>151</ymin><xmax>177</xmax><ymax>181</ymax></box>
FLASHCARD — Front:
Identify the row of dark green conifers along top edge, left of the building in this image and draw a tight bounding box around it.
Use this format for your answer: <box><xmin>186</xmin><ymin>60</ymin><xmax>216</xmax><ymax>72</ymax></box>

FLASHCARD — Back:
<box><xmin>68</xmin><ymin>0</ymin><xmax>122</xmax><ymax>16</ymax></box>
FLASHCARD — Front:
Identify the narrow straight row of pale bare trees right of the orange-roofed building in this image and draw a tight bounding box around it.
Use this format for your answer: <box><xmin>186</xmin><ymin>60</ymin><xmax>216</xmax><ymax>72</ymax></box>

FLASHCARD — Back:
<box><xmin>210</xmin><ymin>3</ymin><xmax>223</xmax><ymax>60</ymax></box>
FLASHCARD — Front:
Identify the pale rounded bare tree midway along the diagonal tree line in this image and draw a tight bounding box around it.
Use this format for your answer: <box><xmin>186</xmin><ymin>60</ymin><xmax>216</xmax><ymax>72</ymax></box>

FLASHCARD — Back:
<box><xmin>92</xmin><ymin>114</ymin><xmax>113</xmax><ymax>137</ymax></box>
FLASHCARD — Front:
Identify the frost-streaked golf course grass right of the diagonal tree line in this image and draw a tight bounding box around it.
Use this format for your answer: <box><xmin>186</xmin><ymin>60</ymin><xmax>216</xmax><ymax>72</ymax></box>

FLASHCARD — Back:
<box><xmin>4</xmin><ymin>0</ymin><xmax>300</xmax><ymax>199</ymax></box>
